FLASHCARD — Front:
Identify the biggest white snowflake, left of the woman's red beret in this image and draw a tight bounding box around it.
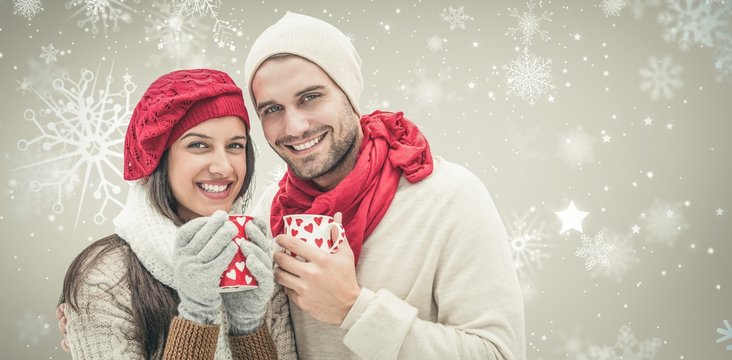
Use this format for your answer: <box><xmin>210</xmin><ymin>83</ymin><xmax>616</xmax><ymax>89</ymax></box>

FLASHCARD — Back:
<box><xmin>16</xmin><ymin>69</ymin><xmax>135</xmax><ymax>224</ymax></box>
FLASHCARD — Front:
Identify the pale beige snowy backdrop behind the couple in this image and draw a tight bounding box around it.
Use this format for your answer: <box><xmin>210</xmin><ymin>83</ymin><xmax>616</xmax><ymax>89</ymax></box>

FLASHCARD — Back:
<box><xmin>0</xmin><ymin>0</ymin><xmax>732</xmax><ymax>360</ymax></box>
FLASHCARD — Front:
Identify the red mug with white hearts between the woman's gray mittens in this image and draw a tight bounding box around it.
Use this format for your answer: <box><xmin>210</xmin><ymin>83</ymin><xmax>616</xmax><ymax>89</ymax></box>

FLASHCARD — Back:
<box><xmin>219</xmin><ymin>215</ymin><xmax>257</xmax><ymax>292</ymax></box>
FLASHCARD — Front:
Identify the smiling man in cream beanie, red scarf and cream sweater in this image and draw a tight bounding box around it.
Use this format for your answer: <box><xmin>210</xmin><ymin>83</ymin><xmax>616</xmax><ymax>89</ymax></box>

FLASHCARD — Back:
<box><xmin>244</xmin><ymin>13</ymin><xmax>526</xmax><ymax>359</ymax></box>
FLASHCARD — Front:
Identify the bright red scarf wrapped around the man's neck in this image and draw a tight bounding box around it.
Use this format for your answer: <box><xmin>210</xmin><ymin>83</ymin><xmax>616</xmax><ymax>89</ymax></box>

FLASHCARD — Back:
<box><xmin>270</xmin><ymin>110</ymin><xmax>432</xmax><ymax>264</ymax></box>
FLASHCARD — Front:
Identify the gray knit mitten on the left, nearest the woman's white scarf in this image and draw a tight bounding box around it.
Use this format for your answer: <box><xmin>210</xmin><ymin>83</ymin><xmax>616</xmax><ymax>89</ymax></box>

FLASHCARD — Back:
<box><xmin>174</xmin><ymin>211</ymin><xmax>238</xmax><ymax>324</ymax></box>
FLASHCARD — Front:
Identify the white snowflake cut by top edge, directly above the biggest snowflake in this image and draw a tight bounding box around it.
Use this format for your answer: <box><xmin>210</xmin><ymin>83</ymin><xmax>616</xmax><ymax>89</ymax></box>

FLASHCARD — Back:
<box><xmin>66</xmin><ymin>0</ymin><xmax>139</xmax><ymax>35</ymax></box>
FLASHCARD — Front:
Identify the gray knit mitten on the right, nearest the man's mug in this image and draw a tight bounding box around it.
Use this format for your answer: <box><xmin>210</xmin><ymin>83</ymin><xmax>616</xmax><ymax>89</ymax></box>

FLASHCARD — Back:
<box><xmin>221</xmin><ymin>219</ymin><xmax>274</xmax><ymax>335</ymax></box>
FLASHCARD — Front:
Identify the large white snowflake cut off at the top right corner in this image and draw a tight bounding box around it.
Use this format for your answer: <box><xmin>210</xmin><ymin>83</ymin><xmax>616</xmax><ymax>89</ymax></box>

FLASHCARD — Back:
<box><xmin>658</xmin><ymin>0</ymin><xmax>732</xmax><ymax>51</ymax></box>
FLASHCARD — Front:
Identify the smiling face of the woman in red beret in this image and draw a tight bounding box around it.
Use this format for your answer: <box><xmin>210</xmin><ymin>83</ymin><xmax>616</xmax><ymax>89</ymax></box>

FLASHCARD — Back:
<box><xmin>168</xmin><ymin>116</ymin><xmax>248</xmax><ymax>221</ymax></box>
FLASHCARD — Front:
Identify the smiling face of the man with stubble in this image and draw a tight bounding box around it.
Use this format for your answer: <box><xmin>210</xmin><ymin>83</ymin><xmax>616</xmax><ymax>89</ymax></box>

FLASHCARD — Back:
<box><xmin>252</xmin><ymin>56</ymin><xmax>362</xmax><ymax>188</ymax></box>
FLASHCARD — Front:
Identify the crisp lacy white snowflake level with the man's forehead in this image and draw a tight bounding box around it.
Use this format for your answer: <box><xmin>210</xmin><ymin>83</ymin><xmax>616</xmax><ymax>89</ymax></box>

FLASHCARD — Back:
<box><xmin>399</xmin><ymin>63</ymin><xmax>457</xmax><ymax>113</ymax></box>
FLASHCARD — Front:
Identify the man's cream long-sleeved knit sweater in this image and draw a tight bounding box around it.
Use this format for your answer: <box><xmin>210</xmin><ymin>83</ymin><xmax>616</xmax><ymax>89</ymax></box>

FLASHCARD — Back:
<box><xmin>251</xmin><ymin>157</ymin><xmax>526</xmax><ymax>360</ymax></box>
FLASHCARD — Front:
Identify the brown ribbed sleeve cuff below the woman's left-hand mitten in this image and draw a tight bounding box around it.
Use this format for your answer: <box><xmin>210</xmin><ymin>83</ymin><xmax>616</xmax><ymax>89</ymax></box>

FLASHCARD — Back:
<box><xmin>163</xmin><ymin>316</ymin><xmax>219</xmax><ymax>359</ymax></box>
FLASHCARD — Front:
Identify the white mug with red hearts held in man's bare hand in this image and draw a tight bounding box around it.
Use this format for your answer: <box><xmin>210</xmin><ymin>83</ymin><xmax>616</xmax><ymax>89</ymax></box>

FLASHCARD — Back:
<box><xmin>283</xmin><ymin>214</ymin><xmax>346</xmax><ymax>261</ymax></box>
